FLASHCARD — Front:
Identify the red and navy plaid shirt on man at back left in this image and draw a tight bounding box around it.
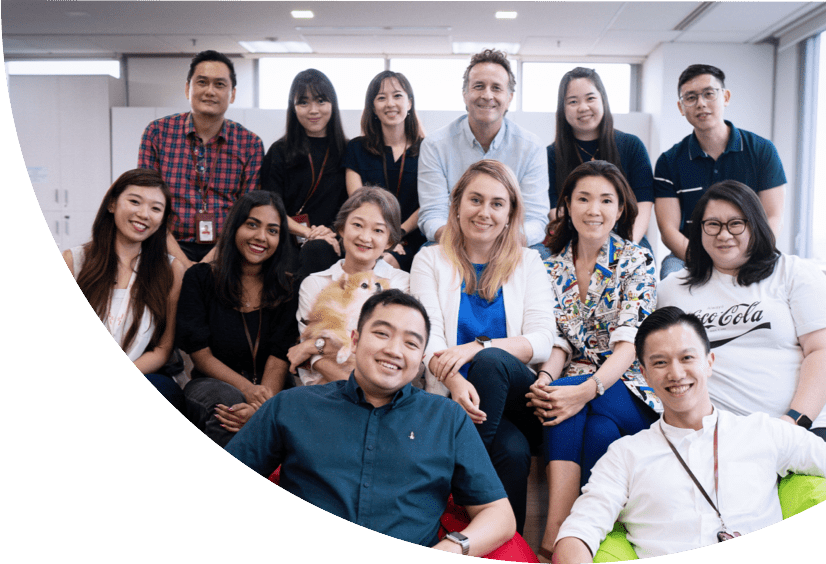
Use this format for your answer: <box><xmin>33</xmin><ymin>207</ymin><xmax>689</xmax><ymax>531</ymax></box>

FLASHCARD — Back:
<box><xmin>138</xmin><ymin>112</ymin><xmax>264</xmax><ymax>242</ymax></box>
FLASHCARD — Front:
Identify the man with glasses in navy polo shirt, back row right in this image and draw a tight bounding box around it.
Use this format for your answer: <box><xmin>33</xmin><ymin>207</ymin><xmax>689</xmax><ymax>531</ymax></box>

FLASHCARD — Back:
<box><xmin>654</xmin><ymin>65</ymin><xmax>786</xmax><ymax>279</ymax></box>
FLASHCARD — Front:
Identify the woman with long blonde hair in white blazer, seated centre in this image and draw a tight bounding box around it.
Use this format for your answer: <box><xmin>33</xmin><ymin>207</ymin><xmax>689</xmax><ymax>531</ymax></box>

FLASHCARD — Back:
<box><xmin>410</xmin><ymin>160</ymin><xmax>561</xmax><ymax>532</ymax></box>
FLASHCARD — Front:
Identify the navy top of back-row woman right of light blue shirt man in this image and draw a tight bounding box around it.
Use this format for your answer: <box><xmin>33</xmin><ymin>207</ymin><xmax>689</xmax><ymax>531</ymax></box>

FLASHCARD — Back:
<box><xmin>548</xmin><ymin>129</ymin><xmax>654</xmax><ymax>208</ymax></box>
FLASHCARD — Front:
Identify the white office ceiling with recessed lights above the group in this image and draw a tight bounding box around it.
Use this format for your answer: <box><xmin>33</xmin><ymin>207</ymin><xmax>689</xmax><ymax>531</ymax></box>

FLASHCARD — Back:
<box><xmin>0</xmin><ymin>0</ymin><xmax>823</xmax><ymax>62</ymax></box>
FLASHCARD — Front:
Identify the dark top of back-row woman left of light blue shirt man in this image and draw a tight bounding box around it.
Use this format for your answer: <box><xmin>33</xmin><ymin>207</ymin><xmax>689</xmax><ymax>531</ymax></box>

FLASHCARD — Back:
<box><xmin>344</xmin><ymin>136</ymin><xmax>419</xmax><ymax>222</ymax></box>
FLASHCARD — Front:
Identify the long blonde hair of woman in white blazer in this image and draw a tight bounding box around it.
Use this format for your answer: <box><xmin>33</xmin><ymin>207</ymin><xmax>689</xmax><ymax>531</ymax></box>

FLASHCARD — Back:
<box><xmin>441</xmin><ymin>159</ymin><xmax>525</xmax><ymax>302</ymax></box>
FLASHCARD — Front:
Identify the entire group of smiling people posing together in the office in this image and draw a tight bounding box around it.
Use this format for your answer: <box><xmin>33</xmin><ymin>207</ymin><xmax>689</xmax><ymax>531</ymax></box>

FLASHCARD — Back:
<box><xmin>64</xmin><ymin>50</ymin><xmax>826</xmax><ymax>562</ymax></box>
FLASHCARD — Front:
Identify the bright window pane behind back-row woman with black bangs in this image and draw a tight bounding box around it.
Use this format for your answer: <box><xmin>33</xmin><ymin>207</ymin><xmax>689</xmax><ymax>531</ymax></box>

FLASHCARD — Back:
<box><xmin>258</xmin><ymin>57</ymin><xmax>384</xmax><ymax>110</ymax></box>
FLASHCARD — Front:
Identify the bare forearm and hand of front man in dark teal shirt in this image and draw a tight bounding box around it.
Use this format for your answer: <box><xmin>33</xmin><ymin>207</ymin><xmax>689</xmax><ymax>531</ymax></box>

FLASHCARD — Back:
<box><xmin>433</xmin><ymin>497</ymin><xmax>516</xmax><ymax>556</ymax></box>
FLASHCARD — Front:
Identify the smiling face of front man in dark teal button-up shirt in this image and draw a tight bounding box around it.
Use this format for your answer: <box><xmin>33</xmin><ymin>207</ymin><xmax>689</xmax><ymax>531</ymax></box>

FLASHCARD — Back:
<box><xmin>353</xmin><ymin>304</ymin><xmax>427</xmax><ymax>407</ymax></box>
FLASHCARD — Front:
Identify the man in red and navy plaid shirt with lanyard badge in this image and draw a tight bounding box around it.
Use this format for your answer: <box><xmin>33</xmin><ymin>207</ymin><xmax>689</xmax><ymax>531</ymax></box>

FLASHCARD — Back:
<box><xmin>138</xmin><ymin>51</ymin><xmax>264</xmax><ymax>267</ymax></box>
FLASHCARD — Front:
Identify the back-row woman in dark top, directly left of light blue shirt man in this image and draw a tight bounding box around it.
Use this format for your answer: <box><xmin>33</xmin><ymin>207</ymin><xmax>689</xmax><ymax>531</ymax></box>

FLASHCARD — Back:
<box><xmin>344</xmin><ymin>70</ymin><xmax>426</xmax><ymax>272</ymax></box>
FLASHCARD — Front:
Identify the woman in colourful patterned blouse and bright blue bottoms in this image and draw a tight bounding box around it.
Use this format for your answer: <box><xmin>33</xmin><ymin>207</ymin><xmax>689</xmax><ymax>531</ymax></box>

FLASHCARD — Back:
<box><xmin>527</xmin><ymin>161</ymin><xmax>662</xmax><ymax>559</ymax></box>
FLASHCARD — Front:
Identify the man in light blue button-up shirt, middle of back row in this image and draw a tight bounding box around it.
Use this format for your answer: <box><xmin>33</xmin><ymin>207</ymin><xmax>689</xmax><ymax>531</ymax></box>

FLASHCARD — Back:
<box><xmin>419</xmin><ymin>49</ymin><xmax>550</xmax><ymax>253</ymax></box>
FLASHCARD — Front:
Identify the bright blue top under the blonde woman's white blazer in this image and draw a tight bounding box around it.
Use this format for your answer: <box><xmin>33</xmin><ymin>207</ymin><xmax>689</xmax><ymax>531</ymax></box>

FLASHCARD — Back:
<box><xmin>456</xmin><ymin>264</ymin><xmax>508</xmax><ymax>378</ymax></box>
